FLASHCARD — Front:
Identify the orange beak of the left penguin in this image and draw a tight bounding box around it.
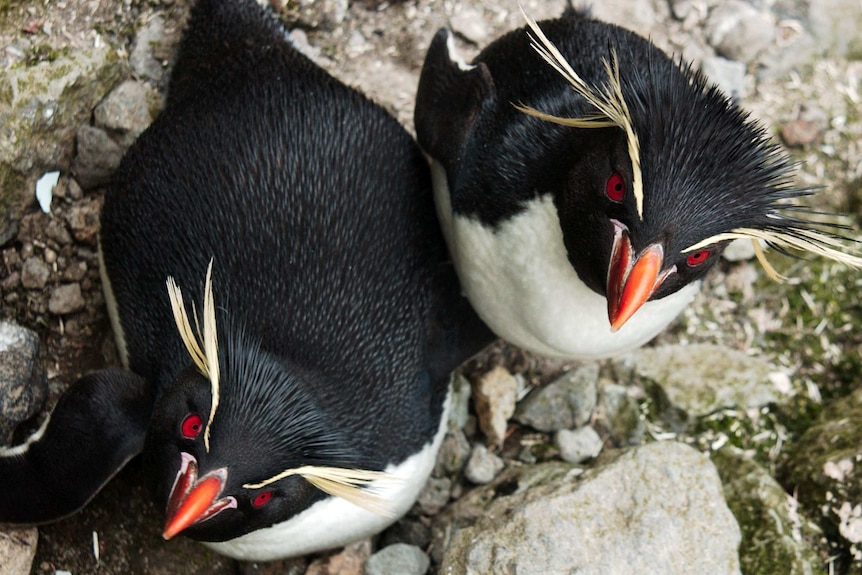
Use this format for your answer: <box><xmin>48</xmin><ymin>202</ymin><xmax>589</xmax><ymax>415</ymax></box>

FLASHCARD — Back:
<box><xmin>162</xmin><ymin>453</ymin><xmax>236</xmax><ymax>540</ymax></box>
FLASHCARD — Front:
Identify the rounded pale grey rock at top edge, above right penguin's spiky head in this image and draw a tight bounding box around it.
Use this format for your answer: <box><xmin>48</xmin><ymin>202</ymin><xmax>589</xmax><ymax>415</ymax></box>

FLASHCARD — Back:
<box><xmin>705</xmin><ymin>0</ymin><xmax>775</xmax><ymax>64</ymax></box>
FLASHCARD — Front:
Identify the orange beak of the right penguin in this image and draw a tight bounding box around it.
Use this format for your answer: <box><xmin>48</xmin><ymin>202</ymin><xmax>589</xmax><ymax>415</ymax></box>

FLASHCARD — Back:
<box><xmin>607</xmin><ymin>220</ymin><xmax>670</xmax><ymax>332</ymax></box>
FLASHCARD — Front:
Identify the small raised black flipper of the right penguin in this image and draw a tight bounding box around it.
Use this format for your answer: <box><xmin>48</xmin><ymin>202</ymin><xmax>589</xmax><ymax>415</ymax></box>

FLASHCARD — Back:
<box><xmin>413</xmin><ymin>28</ymin><xmax>495</xmax><ymax>172</ymax></box>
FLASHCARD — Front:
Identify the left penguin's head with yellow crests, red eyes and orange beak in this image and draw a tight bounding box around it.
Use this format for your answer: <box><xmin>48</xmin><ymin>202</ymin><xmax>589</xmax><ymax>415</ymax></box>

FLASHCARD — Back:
<box><xmin>144</xmin><ymin>264</ymin><xmax>394</xmax><ymax>542</ymax></box>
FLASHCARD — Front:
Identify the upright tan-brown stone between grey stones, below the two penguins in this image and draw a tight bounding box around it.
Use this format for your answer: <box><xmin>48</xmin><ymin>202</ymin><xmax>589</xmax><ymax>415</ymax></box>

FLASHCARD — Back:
<box><xmin>473</xmin><ymin>367</ymin><xmax>518</xmax><ymax>447</ymax></box>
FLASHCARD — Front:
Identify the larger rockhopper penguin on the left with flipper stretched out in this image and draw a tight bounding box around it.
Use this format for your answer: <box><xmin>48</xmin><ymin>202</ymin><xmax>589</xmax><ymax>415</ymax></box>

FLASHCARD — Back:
<box><xmin>0</xmin><ymin>0</ymin><xmax>492</xmax><ymax>560</ymax></box>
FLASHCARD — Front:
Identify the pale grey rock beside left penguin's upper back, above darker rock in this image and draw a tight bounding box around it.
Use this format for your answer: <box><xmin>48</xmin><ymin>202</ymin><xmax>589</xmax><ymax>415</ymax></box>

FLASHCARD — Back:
<box><xmin>95</xmin><ymin>80</ymin><xmax>153</xmax><ymax>148</ymax></box>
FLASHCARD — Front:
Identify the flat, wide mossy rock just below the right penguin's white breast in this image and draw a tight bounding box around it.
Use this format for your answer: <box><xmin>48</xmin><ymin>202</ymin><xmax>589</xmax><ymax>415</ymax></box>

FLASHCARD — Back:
<box><xmin>615</xmin><ymin>344</ymin><xmax>778</xmax><ymax>426</ymax></box>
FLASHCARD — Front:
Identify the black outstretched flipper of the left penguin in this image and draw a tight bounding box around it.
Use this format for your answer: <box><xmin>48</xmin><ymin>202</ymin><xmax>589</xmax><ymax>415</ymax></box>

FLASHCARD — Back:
<box><xmin>0</xmin><ymin>368</ymin><xmax>154</xmax><ymax>524</ymax></box>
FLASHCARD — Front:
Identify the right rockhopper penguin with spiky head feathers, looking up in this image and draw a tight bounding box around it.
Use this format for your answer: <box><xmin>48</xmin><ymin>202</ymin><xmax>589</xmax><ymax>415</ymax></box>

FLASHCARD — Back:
<box><xmin>415</xmin><ymin>9</ymin><xmax>862</xmax><ymax>358</ymax></box>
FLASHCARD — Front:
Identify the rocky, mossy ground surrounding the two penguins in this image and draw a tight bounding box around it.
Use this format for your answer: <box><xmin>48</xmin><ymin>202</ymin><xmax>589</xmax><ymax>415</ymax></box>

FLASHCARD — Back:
<box><xmin>0</xmin><ymin>0</ymin><xmax>862</xmax><ymax>575</ymax></box>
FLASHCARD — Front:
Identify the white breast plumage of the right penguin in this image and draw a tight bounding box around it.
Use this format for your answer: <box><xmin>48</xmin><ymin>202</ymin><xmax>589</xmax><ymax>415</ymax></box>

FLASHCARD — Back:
<box><xmin>431</xmin><ymin>160</ymin><xmax>700</xmax><ymax>359</ymax></box>
